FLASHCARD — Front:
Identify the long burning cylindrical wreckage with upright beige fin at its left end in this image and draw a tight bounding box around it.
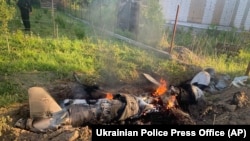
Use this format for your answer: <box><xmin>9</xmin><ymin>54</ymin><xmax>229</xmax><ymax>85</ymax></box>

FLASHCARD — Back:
<box><xmin>15</xmin><ymin>74</ymin><xmax>206</xmax><ymax>132</ymax></box>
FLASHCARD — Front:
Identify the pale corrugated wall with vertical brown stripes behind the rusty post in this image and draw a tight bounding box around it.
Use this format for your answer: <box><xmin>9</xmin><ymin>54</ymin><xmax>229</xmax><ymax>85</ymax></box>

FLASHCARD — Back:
<box><xmin>160</xmin><ymin>0</ymin><xmax>250</xmax><ymax>30</ymax></box>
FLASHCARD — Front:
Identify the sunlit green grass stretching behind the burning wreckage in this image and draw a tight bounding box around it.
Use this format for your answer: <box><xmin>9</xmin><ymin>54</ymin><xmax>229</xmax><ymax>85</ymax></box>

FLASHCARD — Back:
<box><xmin>0</xmin><ymin>9</ymin><xmax>250</xmax><ymax>107</ymax></box>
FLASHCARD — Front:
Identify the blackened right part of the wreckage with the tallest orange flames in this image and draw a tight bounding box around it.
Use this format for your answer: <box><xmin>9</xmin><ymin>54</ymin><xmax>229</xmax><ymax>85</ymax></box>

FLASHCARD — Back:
<box><xmin>135</xmin><ymin>74</ymin><xmax>195</xmax><ymax>125</ymax></box>
